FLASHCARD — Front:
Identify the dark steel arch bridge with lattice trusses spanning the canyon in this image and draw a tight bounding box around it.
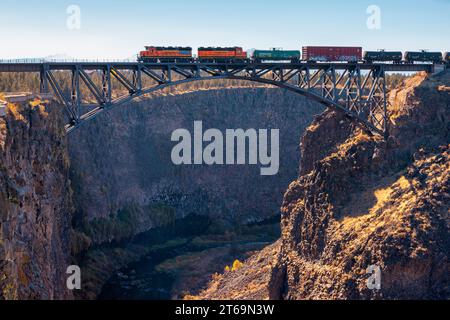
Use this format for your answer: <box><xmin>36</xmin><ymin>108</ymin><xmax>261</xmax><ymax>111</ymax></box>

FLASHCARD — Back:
<box><xmin>0</xmin><ymin>62</ymin><xmax>433</xmax><ymax>137</ymax></box>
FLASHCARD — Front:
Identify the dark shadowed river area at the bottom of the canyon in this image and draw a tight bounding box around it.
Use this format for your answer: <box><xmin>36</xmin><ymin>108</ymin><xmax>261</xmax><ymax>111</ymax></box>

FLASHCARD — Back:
<box><xmin>98</xmin><ymin>216</ymin><xmax>279</xmax><ymax>300</ymax></box>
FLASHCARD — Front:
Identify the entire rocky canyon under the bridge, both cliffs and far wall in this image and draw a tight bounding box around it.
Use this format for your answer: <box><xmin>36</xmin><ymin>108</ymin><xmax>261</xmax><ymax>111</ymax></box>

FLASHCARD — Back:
<box><xmin>0</xmin><ymin>71</ymin><xmax>450</xmax><ymax>300</ymax></box>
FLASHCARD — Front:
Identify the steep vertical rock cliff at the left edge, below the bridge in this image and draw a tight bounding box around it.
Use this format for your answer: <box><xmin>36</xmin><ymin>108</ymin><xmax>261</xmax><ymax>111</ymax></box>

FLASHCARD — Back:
<box><xmin>0</xmin><ymin>101</ymin><xmax>72</xmax><ymax>300</ymax></box>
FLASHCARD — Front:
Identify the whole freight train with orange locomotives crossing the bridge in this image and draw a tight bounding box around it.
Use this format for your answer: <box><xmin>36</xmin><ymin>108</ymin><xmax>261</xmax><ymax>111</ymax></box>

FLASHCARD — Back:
<box><xmin>138</xmin><ymin>46</ymin><xmax>450</xmax><ymax>64</ymax></box>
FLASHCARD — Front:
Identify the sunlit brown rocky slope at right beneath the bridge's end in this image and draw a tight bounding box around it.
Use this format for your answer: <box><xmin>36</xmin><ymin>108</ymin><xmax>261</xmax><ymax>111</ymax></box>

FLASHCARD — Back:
<box><xmin>196</xmin><ymin>72</ymin><xmax>450</xmax><ymax>299</ymax></box>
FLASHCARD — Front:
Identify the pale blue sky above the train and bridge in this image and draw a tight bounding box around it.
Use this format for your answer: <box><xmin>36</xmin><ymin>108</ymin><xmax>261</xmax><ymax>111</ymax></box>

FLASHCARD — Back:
<box><xmin>0</xmin><ymin>0</ymin><xmax>450</xmax><ymax>60</ymax></box>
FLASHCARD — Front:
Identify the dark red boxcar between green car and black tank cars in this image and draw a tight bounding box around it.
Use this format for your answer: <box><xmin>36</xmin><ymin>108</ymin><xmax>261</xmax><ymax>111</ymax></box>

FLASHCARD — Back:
<box><xmin>302</xmin><ymin>47</ymin><xmax>363</xmax><ymax>62</ymax></box>
